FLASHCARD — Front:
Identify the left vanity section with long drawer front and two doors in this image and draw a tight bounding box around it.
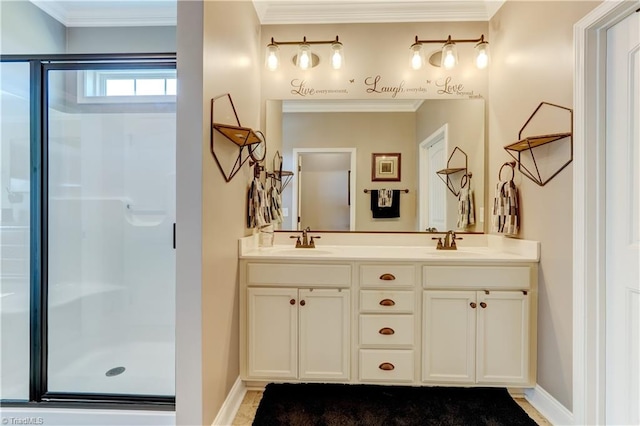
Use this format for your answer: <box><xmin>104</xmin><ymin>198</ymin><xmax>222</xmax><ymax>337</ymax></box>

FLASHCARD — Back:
<box><xmin>242</xmin><ymin>263</ymin><xmax>351</xmax><ymax>381</ymax></box>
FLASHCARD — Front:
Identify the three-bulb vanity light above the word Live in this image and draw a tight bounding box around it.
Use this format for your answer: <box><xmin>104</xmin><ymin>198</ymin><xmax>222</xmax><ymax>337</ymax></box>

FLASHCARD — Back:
<box><xmin>265</xmin><ymin>36</ymin><xmax>344</xmax><ymax>71</ymax></box>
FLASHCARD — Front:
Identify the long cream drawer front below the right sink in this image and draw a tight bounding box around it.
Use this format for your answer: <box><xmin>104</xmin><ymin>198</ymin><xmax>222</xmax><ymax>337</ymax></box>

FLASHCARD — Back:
<box><xmin>422</xmin><ymin>266</ymin><xmax>531</xmax><ymax>290</ymax></box>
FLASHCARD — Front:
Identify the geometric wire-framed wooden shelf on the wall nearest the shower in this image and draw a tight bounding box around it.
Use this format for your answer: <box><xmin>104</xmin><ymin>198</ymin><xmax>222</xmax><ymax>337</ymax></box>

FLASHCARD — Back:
<box><xmin>210</xmin><ymin>93</ymin><xmax>267</xmax><ymax>182</ymax></box>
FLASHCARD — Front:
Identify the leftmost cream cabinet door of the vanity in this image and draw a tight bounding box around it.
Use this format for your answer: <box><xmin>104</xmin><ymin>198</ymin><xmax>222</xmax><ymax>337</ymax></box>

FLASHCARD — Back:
<box><xmin>247</xmin><ymin>288</ymin><xmax>298</xmax><ymax>379</ymax></box>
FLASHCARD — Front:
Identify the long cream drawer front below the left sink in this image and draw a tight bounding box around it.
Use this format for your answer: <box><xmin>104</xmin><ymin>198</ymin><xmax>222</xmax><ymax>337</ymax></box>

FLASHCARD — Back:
<box><xmin>247</xmin><ymin>263</ymin><xmax>351</xmax><ymax>287</ymax></box>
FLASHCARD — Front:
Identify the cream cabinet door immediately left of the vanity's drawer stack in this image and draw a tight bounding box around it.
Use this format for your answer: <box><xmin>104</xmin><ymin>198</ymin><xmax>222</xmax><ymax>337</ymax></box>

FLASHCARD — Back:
<box><xmin>298</xmin><ymin>289</ymin><xmax>351</xmax><ymax>380</ymax></box>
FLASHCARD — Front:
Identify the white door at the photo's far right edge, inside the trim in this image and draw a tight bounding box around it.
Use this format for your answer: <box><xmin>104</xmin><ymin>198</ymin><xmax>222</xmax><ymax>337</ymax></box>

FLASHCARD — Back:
<box><xmin>605</xmin><ymin>13</ymin><xmax>640</xmax><ymax>425</ymax></box>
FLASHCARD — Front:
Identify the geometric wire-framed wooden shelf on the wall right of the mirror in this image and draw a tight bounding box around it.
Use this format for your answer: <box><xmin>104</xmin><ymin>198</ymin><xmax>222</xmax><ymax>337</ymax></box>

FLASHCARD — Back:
<box><xmin>504</xmin><ymin>102</ymin><xmax>573</xmax><ymax>186</ymax></box>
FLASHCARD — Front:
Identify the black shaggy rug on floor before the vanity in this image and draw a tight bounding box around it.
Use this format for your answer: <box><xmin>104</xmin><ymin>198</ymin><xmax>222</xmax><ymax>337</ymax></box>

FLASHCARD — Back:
<box><xmin>253</xmin><ymin>383</ymin><xmax>536</xmax><ymax>426</ymax></box>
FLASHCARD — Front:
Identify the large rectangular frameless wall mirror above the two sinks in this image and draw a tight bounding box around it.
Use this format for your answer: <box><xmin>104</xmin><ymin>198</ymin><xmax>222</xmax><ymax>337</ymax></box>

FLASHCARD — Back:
<box><xmin>266</xmin><ymin>98</ymin><xmax>486</xmax><ymax>232</ymax></box>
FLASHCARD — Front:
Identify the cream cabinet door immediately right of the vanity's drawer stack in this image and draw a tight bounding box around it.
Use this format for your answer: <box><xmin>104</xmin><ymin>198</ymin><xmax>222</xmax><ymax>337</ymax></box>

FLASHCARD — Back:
<box><xmin>422</xmin><ymin>290</ymin><xmax>477</xmax><ymax>383</ymax></box>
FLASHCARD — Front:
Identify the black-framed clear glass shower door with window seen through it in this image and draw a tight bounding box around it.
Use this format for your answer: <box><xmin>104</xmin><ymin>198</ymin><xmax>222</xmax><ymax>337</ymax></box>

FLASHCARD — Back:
<box><xmin>44</xmin><ymin>63</ymin><xmax>176</xmax><ymax>396</ymax></box>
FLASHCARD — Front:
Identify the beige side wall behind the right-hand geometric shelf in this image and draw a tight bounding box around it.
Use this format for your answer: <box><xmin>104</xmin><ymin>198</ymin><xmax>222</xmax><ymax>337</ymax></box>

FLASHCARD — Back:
<box><xmin>488</xmin><ymin>1</ymin><xmax>599</xmax><ymax>410</ymax></box>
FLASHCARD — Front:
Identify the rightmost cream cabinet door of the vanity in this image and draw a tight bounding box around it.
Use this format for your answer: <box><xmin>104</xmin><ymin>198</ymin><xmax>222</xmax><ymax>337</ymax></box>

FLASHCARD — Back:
<box><xmin>476</xmin><ymin>291</ymin><xmax>531</xmax><ymax>384</ymax></box>
